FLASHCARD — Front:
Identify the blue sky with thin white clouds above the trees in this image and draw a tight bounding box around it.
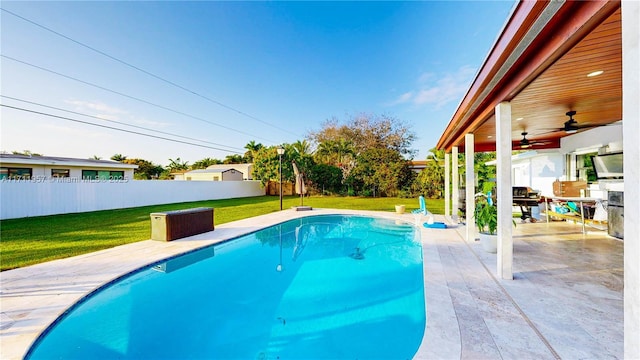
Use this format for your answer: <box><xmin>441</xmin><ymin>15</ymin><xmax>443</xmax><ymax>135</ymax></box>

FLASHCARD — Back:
<box><xmin>0</xmin><ymin>1</ymin><xmax>513</xmax><ymax>165</ymax></box>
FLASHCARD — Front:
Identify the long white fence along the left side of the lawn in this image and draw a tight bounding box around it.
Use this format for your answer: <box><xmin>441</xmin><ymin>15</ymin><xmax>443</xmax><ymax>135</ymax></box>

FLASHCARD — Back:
<box><xmin>0</xmin><ymin>180</ymin><xmax>265</xmax><ymax>219</ymax></box>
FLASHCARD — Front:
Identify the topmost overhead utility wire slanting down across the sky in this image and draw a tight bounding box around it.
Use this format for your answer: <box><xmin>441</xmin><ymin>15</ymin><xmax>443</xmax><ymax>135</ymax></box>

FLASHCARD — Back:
<box><xmin>2</xmin><ymin>8</ymin><xmax>299</xmax><ymax>136</ymax></box>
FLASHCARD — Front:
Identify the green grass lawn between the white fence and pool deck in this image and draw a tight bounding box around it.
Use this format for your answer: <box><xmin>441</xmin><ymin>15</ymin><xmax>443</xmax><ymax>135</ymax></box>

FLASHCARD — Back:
<box><xmin>0</xmin><ymin>196</ymin><xmax>444</xmax><ymax>271</ymax></box>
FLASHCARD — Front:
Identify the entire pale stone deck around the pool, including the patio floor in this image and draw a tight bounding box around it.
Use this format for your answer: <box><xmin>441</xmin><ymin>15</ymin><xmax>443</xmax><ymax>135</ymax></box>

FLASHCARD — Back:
<box><xmin>0</xmin><ymin>209</ymin><xmax>624</xmax><ymax>359</ymax></box>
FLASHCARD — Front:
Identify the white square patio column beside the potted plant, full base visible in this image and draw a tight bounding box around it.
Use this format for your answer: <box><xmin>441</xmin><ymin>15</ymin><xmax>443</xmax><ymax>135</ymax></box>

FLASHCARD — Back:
<box><xmin>495</xmin><ymin>102</ymin><xmax>513</xmax><ymax>280</ymax></box>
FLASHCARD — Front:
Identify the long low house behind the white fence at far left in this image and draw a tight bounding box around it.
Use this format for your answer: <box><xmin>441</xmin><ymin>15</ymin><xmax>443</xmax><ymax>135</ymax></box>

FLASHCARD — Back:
<box><xmin>0</xmin><ymin>154</ymin><xmax>138</xmax><ymax>182</ymax></box>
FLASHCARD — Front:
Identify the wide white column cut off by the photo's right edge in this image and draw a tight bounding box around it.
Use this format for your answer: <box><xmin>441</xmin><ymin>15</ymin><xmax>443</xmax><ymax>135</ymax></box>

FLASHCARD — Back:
<box><xmin>622</xmin><ymin>1</ymin><xmax>640</xmax><ymax>359</ymax></box>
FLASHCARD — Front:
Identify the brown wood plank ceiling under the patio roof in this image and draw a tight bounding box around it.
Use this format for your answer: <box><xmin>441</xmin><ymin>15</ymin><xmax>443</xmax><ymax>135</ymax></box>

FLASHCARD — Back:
<box><xmin>474</xmin><ymin>8</ymin><xmax>622</xmax><ymax>151</ymax></box>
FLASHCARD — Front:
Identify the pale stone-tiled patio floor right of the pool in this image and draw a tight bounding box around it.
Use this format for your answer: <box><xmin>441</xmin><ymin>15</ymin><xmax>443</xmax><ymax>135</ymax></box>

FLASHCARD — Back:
<box><xmin>416</xmin><ymin>215</ymin><xmax>625</xmax><ymax>359</ymax></box>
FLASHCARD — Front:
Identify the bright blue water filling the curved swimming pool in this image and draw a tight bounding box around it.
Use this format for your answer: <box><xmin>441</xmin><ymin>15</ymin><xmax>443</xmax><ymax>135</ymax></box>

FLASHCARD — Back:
<box><xmin>27</xmin><ymin>215</ymin><xmax>426</xmax><ymax>359</ymax></box>
